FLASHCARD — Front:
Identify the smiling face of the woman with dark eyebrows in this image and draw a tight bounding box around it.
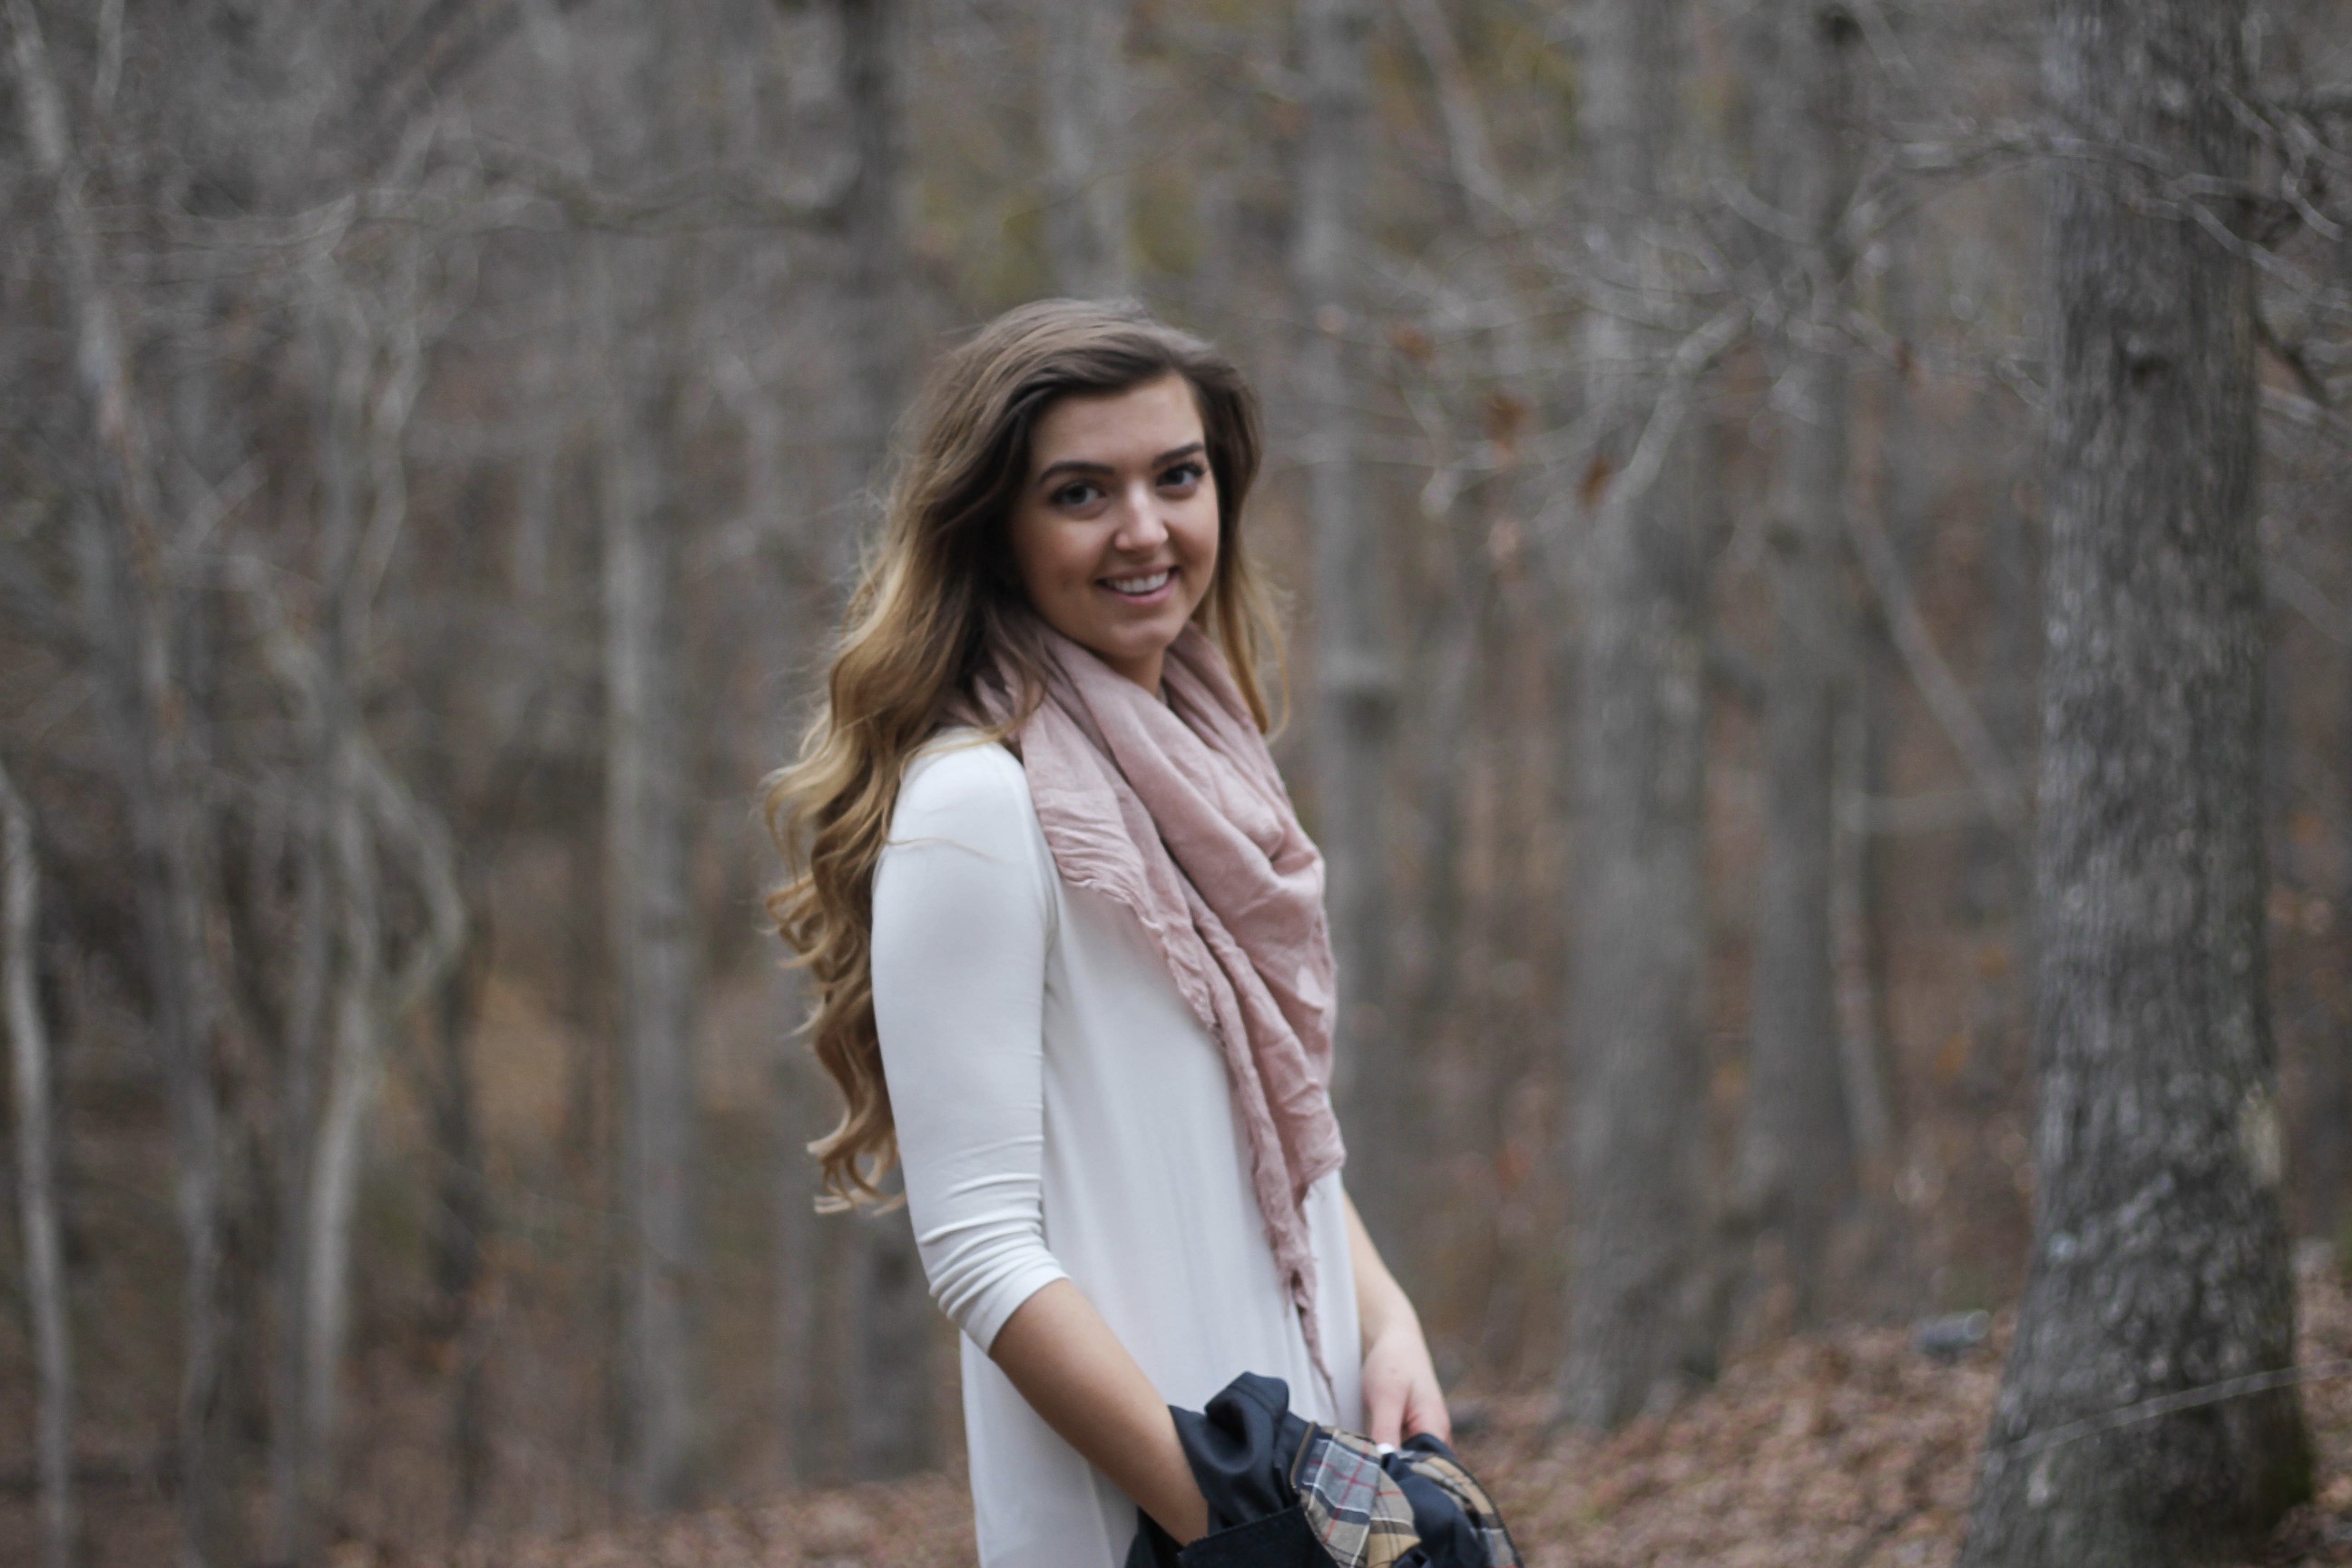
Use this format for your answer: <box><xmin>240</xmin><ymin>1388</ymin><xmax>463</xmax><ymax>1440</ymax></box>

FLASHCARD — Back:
<box><xmin>1012</xmin><ymin>374</ymin><xmax>1216</xmax><ymax>693</ymax></box>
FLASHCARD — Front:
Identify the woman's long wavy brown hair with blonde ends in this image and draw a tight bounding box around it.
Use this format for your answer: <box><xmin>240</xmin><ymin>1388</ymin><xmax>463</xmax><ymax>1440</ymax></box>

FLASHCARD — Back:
<box><xmin>764</xmin><ymin>299</ymin><xmax>1282</xmax><ymax>1209</ymax></box>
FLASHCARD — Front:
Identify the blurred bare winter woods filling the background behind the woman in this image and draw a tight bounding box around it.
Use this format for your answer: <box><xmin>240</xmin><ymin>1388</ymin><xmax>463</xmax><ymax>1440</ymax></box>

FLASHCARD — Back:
<box><xmin>0</xmin><ymin>0</ymin><xmax>2352</xmax><ymax>1563</ymax></box>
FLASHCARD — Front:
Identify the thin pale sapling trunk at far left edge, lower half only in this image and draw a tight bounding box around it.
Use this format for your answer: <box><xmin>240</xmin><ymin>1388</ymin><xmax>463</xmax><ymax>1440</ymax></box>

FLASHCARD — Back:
<box><xmin>0</xmin><ymin>752</ymin><xmax>75</xmax><ymax>1568</ymax></box>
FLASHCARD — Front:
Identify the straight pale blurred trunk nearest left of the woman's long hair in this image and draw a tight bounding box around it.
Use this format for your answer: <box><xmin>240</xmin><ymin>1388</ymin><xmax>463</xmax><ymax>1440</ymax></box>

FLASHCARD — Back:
<box><xmin>600</xmin><ymin>315</ymin><xmax>694</xmax><ymax>1509</ymax></box>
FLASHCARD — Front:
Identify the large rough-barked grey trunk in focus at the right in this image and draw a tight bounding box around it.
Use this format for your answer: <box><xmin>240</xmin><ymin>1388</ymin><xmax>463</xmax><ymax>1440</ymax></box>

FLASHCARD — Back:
<box><xmin>1962</xmin><ymin>0</ymin><xmax>2309</xmax><ymax>1568</ymax></box>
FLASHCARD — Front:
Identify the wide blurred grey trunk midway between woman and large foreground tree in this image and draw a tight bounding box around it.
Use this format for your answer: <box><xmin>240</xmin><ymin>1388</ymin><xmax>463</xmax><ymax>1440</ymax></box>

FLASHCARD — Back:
<box><xmin>1559</xmin><ymin>0</ymin><xmax>1708</xmax><ymax>1427</ymax></box>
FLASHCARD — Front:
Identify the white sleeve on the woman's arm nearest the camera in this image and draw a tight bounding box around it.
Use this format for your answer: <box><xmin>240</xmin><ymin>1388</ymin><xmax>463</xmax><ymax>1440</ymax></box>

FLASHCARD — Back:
<box><xmin>873</xmin><ymin>740</ymin><xmax>1068</xmax><ymax>1352</ymax></box>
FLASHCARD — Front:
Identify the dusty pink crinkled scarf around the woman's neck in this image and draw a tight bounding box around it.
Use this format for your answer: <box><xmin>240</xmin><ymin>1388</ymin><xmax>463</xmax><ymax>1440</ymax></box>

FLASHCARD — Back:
<box><xmin>992</xmin><ymin>623</ymin><xmax>1346</xmax><ymax>1382</ymax></box>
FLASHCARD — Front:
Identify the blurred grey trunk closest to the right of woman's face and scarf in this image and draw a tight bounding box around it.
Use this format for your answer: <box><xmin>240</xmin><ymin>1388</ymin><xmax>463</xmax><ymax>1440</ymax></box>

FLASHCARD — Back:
<box><xmin>1291</xmin><ymin>0</ymin><xmax>1414</xmax><ymax>1241</ymax></box>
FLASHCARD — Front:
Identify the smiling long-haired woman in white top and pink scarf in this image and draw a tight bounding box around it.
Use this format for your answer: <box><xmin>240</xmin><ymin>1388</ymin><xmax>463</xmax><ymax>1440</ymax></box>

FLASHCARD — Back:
<box><xmin>769</xmin><ymin>301</ymin><xmax>1449</xmax><ymax>1568</ymax></box>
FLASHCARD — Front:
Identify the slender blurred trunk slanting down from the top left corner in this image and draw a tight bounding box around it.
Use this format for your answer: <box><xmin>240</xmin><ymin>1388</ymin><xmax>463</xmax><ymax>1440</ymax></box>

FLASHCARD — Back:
<box><xmin>7</xmin><ymin>0</ymin><xmax>223</xmax><ymax>1565</ymax></box>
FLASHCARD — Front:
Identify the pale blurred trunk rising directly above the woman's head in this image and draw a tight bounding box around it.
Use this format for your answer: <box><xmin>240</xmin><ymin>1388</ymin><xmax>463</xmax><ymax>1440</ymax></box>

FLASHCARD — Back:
<box><xmin>1040</xmin><ymin>0</ymin><xmax>1133</xmax><ymax>299</ymax></box>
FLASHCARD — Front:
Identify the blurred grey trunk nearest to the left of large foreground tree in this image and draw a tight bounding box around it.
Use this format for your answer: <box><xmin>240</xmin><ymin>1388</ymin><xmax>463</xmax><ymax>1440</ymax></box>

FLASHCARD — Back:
<box><xmin>1736</xmin><ymin>0</ymin><xmax>1858</xmax><ymax>1321</ymax></box>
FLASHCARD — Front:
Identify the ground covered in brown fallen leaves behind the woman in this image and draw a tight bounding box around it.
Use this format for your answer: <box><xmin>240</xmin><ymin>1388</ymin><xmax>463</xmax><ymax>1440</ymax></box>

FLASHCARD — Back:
<box><xmin>423</xmin><ymin>1267</ymin><xmax>2352</xmax><ymax>1568</ymax></box>
